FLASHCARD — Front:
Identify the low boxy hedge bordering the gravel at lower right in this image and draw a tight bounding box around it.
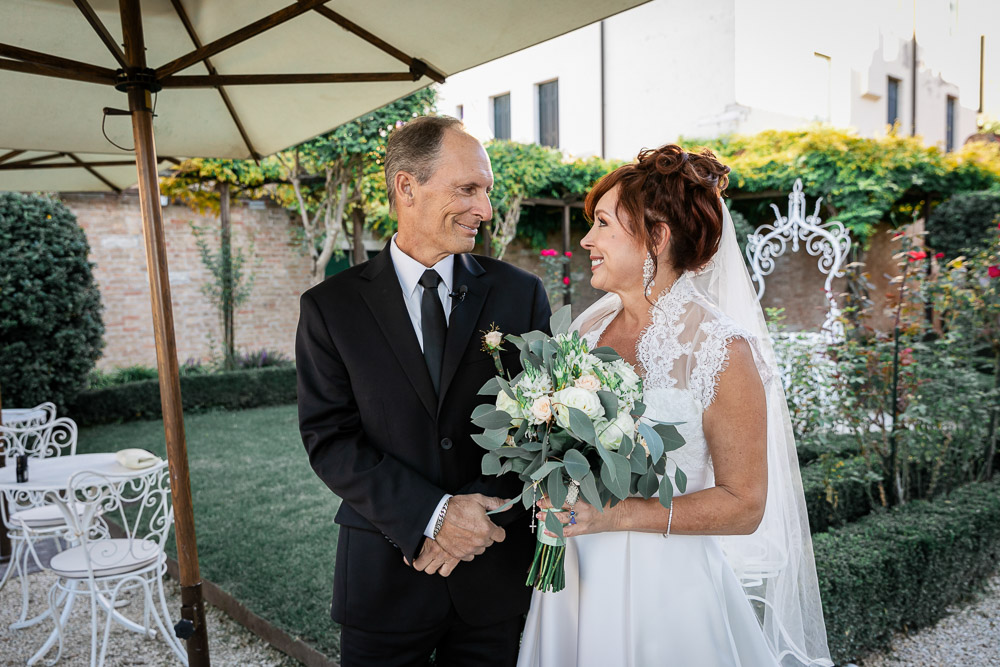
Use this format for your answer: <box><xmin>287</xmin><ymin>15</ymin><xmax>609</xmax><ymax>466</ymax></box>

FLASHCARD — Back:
<box><xmin>813</xmin><ymin>482</ymin><xmax>1000</xmax><ymax>663</ymax></box>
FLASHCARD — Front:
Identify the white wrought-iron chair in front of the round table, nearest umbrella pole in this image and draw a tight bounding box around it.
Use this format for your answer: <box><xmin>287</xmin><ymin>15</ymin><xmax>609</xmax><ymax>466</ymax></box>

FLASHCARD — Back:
<box><xmin>28</xmin><ymin>461</ymin><xmax>187</xmax><ymax>667</ymax></box>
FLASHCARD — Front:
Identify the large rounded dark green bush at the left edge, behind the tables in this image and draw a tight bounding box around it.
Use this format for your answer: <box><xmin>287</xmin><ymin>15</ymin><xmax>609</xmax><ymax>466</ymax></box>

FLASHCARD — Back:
<box><xmin>0</xmin><ymin>193</ymin><xmax>104</xmax><ymax>407</ymax></box>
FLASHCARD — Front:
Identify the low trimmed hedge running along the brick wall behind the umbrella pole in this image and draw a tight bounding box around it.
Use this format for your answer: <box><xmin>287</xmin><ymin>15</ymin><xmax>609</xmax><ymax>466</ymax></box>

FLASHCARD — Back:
<box><xmin>67</xmin><ymin>367</ymin><xmax>296</xmax><ymax>426</ymax></box>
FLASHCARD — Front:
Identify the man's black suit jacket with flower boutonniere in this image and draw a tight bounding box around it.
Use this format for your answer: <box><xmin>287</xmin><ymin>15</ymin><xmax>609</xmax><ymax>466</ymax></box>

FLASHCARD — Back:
<box><xmin>295</xmin><ymin>246</ymin><xmax>550</xmax><ymax>632</ymax></box>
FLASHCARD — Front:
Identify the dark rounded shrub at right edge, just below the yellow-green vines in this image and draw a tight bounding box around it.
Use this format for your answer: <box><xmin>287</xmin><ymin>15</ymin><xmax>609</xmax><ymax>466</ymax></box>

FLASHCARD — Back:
<box><xmin>927</xmin><ymin>190</ymin><xmax>1000</xmax><ymax>259</ymax></box>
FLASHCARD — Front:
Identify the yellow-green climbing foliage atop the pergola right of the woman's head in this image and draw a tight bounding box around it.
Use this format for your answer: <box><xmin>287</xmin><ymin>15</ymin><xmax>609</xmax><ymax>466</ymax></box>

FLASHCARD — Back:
<box><xmin>680</xmin><ymin>126</ymin><xmax>1000</xmax><ymax>240</ymax></box>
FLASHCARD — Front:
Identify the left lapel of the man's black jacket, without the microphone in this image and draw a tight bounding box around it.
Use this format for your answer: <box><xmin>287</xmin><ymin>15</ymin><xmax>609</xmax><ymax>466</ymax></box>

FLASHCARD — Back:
<box><xmin>361</xmin><ymin>245</ymin><xmax>438</xmax><ymax>417</ymax></box>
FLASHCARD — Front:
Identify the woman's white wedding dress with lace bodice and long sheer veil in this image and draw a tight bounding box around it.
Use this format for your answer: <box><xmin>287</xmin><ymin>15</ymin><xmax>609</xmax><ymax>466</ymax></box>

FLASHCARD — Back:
<box><xmin>518</xmin><ymin>205</ymin><xmax>832</xmax><ymax>667</ymax></box>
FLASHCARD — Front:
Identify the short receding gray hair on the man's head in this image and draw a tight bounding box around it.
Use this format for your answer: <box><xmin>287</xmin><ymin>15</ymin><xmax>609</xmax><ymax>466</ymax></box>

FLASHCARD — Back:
<box><xmin>385</xmin><ymin>116</ymin><xmax>465</xmax><ymax>211</ymax></box>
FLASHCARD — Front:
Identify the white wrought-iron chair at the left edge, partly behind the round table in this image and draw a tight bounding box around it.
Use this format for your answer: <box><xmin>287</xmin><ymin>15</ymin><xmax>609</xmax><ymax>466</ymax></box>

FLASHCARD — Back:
<box><xmin>0</xmin><ymin>414</ymin><xmax>77</xmax><ymax>629</ymax></box>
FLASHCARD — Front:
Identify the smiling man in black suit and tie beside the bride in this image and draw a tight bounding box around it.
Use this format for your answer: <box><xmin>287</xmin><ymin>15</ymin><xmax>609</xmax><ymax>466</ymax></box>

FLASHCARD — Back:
<box><xmin>296</xmin><ymin>116</ymin><xmax>550</xmax><ymax>667</ymax></box>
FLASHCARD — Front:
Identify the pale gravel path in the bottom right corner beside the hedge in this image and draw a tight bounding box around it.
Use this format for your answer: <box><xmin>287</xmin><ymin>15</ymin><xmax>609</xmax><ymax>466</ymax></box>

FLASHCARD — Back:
<box><xmin>858</xmin><ymin>574</ymin><xmax>1000</xmax><ymax>667</ymax></box>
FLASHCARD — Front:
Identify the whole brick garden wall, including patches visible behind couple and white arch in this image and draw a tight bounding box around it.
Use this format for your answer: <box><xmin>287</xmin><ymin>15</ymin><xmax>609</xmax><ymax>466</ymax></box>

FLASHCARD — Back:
<box><xmin>62</xmin><ymin>194</ymin><xmax>895</xmax><ymax>369</ymax></box>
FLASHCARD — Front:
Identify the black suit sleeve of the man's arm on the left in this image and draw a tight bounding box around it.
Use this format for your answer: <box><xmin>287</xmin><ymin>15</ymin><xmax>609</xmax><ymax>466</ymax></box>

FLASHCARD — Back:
<box><xmin>295</xmin><ymin>293</ymin><xmax>445</xmax><ymax>562</ymax></box>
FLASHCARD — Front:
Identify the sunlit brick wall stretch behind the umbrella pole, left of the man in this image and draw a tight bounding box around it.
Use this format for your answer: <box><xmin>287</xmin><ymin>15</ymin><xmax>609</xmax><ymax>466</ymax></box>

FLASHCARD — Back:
<box><xmin>68</xmin><ymin>193</ymin><xmax>310</xmax><ymax>369</ymax></box>
